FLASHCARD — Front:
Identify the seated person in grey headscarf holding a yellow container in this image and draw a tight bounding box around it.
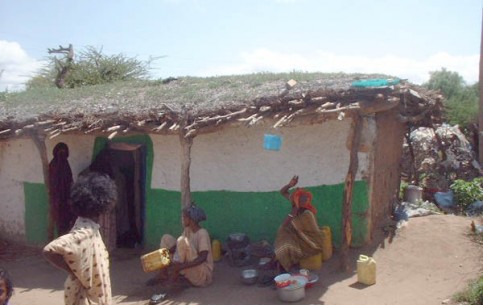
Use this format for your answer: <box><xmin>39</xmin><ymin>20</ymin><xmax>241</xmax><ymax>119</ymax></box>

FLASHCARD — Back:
<box><xmin>147</xmin><ymin>204</ymin><xmax>214</xmax><ymax>287</ymax></box>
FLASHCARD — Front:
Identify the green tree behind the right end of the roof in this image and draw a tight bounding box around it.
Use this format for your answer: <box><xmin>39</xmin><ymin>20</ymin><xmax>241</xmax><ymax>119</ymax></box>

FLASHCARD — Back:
<box><xmin>423</xmin><ymin>68</ymin><xmax>479</xmax><ymax>128</ymax></box>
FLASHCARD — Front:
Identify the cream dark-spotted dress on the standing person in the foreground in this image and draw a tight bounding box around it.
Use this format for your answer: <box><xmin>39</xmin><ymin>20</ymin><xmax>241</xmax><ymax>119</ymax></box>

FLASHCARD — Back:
<box><xmin>44</xmin><ymin>217</ymin><xmax>112</xmax><ymax>305</ymax></box>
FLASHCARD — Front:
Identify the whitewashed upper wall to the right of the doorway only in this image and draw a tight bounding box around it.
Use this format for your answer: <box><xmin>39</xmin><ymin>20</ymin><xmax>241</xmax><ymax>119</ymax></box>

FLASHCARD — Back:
<box><xmin>152</xmin><ymin>119</ymin><xmax>375</xmax><ymax>192</ymax></box>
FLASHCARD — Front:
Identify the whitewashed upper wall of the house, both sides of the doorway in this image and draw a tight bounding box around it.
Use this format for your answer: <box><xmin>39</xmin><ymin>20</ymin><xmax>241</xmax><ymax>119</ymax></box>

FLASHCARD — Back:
<box><xmin>0</xmin><ymin>119</ymin><xmax>375</xmax><ymax>237</ymax></box>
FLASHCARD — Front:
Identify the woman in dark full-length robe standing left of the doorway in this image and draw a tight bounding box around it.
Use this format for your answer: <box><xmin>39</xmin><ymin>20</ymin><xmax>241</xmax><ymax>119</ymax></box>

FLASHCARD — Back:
<box><xmin>48</xmin><ymin>142</ymin><xmax>75</xmax><ymax>240</ymax></box>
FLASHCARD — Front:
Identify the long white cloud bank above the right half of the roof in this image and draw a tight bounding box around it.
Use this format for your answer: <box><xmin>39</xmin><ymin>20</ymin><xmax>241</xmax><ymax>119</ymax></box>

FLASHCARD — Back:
<box><xmin>201</xmin><ymin>49</ymin><xmax>480</xmax><ymax>84</ymax></box>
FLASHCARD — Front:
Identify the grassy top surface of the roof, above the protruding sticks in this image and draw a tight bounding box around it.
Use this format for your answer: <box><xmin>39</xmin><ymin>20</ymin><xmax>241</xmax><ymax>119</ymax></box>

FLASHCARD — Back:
<box><xmin>0</xmin><ymin>72</ymin><xmax>394</xmax><ymax>120</ymax></box>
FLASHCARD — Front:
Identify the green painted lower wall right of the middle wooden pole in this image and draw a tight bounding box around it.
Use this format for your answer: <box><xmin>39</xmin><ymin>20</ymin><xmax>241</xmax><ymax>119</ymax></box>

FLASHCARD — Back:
<box><xmin>192</xmin><ymin>181</ymin><xmax>369</xmax><ymax>247</ymax></box>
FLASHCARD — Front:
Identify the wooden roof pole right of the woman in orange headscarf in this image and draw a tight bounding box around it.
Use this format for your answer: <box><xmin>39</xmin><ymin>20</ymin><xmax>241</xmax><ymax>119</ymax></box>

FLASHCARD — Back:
<box><xmin>340</xmin><ymin>114</ymin><xmax>362</xmax><ymax>271</ymax></box>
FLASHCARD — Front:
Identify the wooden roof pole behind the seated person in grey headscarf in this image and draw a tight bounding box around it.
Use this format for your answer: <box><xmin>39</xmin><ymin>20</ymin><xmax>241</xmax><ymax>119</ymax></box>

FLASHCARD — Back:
<box><xmin>179</xmin><ymin>116</ymin><xmax>193</xmax><ymax>209</ymax></box>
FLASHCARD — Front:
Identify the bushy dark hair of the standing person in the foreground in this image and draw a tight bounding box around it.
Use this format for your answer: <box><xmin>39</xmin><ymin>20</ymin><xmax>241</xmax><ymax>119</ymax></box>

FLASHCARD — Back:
<box><xmin>71</xmin><ymin>172</ymin><xmax>117</xmax><ymax>218</ymax></box>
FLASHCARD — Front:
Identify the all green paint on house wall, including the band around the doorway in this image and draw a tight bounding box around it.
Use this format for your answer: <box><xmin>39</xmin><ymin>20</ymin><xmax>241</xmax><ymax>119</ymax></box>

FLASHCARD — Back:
<box><xmin>24</xmin><ymin>135</ymin><xmax>369</xmax><ymax>248</ymax></box>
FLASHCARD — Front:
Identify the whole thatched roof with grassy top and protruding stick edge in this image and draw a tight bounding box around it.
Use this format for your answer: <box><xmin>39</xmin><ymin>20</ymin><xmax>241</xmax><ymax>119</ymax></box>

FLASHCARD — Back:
<box><xmin>0</xmin><ymin>73</ymin><xmax>441</xmax><ymax>139</ymax></box>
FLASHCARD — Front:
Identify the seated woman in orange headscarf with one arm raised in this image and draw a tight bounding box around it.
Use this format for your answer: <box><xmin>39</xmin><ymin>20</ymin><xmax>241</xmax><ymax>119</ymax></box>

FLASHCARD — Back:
<box><xmin>274</xmin><ymin>176</ymin><xmax>324</xmax><ymax>272</ymax></box>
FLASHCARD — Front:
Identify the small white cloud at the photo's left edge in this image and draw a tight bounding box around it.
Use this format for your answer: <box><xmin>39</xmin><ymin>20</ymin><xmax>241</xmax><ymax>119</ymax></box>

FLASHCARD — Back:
<box><xmin>0</xmin><ymin>40</ymin><xmax>44</xmax><ymax>91</ymax></box>
